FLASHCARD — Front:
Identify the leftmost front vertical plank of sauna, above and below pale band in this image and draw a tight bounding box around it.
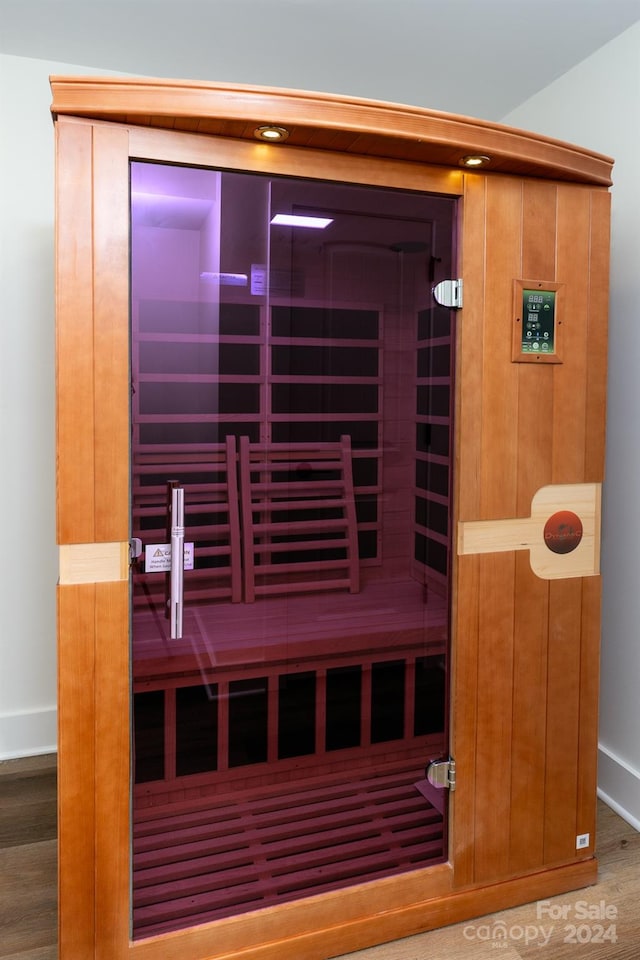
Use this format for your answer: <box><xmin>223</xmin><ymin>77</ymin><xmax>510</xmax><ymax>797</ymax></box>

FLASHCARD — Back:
<box><xmin>56</xmin><ymin>123</ymin><xmax>96</xmax><ymax>957</ymax></box>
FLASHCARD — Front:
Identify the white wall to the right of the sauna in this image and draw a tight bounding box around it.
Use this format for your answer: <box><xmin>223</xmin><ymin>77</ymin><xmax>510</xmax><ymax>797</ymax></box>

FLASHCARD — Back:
<box><xmin>503</xmin><ymin>23</ymin><xmax>640</xmax><ymax>829</ymax></box>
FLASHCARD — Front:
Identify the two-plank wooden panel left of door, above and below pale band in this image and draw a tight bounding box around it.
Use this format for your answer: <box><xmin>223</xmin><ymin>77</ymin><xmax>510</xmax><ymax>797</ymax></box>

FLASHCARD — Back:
<box><xmin>56</xmin><ymin>122</ymin><xmax>129</xmax><ymax>957</ymax></box>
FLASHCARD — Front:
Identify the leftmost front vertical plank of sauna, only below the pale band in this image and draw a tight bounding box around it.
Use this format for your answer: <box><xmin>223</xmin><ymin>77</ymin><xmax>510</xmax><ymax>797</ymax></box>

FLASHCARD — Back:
<box><xmin>58</xmin><ymin>584</ymin><xmax>96</xmax><ymax>958</ymax></box>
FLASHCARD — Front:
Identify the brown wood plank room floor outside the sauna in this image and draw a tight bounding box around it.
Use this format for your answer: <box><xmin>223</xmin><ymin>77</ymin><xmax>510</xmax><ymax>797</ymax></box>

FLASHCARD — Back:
<box><xmin>0</xmin><ymin>757</ymin><xmax>640</xmax><ymax>960</ymax></box>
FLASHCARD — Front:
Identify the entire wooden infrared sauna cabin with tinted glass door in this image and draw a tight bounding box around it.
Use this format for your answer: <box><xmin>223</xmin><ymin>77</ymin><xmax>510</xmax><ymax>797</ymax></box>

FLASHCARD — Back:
<box><xmin>52</xmin><ymin>77</ymin><xmax>612</xmax><ymax>960</ymax></box>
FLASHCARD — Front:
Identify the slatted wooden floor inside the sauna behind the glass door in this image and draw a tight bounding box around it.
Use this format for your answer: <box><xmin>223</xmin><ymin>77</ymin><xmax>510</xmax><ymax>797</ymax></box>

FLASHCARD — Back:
<box><xmin>133</xmin><ymin>760</ymin><xmax>444</xmax><ymax>936</ymax></box>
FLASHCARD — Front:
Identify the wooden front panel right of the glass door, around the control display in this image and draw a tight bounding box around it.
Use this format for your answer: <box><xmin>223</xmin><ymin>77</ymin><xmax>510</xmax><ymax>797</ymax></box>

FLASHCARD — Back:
<box><xmin>454</xmin><ymin>177</ymin><xmax>608</xmax><ymax>882</ymax></box>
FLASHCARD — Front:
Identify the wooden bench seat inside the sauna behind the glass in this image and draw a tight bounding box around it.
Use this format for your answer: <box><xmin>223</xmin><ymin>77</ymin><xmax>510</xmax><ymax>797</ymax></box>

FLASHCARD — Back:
<box><xmin>133</xmin><ymin>580</ymin><xmax>448</xmax><ymax>687</ymax></box>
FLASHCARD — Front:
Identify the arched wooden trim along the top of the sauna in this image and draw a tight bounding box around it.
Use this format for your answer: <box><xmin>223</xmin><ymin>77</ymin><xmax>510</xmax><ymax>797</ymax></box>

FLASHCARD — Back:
<box><xmin>51</xmin><ymin>77</ymin><xmax>613</xmax><ymax>186</ymax></box>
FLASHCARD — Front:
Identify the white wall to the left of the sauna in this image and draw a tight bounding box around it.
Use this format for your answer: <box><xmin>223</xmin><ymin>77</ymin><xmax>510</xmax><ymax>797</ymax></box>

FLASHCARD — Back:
<box><xmin>0</xmin><ymin>56</ymin><xmax>123</xmax><ymax>760</ymax></box>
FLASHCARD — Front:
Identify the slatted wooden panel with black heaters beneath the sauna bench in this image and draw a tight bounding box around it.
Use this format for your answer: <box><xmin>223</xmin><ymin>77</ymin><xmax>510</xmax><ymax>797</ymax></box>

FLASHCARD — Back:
<box><xmin>134</xmin><ymin>645</ymin><xmax>446</xmax><ymax>810</ymax></box>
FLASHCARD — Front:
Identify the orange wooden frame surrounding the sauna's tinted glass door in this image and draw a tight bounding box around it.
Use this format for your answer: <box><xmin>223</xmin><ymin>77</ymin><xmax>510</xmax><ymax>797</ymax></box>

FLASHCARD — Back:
<box><xmin>56</xmin><ymin>117</ymin><xmax>595</xmax><ymax>960</ymax></box>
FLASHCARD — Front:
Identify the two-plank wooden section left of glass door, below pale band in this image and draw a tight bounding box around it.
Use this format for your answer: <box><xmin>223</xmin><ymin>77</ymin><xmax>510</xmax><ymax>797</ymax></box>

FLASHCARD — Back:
<box><xmin>58</xmin><ymin>581</ymin><xmax>129</xmax><ymax>957</ymax></box>
